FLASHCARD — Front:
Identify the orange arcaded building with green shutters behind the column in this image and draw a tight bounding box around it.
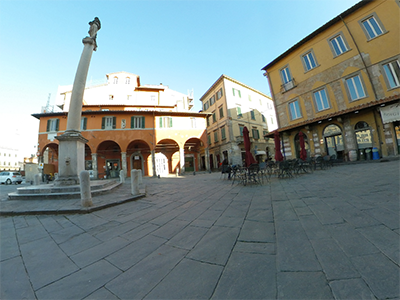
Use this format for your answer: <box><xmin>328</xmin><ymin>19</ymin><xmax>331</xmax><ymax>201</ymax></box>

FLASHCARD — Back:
<box><xmin>33</xmin><ymin>72</ymin><xmax>207</xmax><ymax>179</ymax></box>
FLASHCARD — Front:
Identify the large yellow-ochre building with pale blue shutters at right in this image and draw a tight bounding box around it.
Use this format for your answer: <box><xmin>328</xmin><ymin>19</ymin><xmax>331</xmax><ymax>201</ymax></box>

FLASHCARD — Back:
<box><xmin>263</xmin><ymin>0</ymin><xmax>400</xmax><ymax>160</ymax></box>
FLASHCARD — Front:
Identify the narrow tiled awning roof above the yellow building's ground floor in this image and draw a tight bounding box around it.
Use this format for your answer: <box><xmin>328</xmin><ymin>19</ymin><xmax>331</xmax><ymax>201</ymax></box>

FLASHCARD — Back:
<box><xmin>265</xmin><ymin>95</ymin><xmax>400</xmax><ymax>137</ymax></box>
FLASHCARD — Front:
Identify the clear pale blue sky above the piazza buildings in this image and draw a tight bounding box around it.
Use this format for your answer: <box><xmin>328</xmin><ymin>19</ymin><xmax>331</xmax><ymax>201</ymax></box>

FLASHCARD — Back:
<box><xmin>0</xmin><ymin>0</ymin><xmax>359</xmax><ymax>155</ymax></box>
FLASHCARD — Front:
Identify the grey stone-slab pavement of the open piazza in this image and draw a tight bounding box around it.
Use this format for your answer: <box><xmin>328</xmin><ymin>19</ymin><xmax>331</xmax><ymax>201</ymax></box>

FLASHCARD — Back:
<box><xmin>0</xmin><ymin>160</ymin><xmax>400</xmax><ymax>300</ymax></box>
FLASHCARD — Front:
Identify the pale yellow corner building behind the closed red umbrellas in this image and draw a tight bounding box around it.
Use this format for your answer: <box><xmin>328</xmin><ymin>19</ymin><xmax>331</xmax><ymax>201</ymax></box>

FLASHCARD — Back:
<box><xmin>200</xmin><ymin>75</ymin><xmax>277</xmax><ymax>169</ymax></box>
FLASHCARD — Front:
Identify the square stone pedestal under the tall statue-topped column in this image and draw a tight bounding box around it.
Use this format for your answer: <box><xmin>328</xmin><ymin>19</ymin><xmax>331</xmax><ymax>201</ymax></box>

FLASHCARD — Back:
<box><xmin>54</xmin><ymin>131</ymin><xmax>88</xmax><ymax>186</ymax></box>
